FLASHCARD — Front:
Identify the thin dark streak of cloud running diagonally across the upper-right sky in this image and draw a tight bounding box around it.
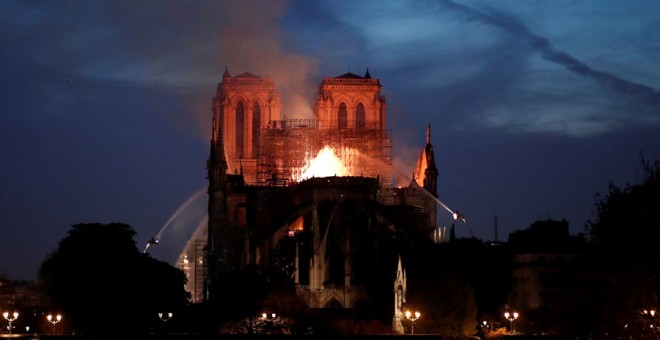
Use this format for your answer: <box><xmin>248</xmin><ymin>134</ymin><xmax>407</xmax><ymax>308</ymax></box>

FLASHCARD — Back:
<box><xmin>440</xmin><ymin>0</ymin><xmax>660</xmax><ymax>113</ymax></box>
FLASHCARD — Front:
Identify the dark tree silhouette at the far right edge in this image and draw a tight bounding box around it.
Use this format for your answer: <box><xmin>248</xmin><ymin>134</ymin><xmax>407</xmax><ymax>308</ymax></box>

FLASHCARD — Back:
<box><xmin>588</xmin><ymin>158</ymin><xmax>660</xmax><ymax>337</ymax></box>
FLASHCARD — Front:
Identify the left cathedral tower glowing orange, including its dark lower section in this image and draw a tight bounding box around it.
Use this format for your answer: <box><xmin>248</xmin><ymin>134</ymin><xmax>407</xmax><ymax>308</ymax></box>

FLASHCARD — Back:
<box><xmin>206</xmin><ymin>70</ymin><xmax>264</xmax><ymax>299</ymax></box>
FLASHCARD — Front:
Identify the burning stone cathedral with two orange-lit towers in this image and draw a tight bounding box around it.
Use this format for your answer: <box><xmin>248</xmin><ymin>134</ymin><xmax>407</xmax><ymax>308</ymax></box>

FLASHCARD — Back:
<box><xmin>180</xmin><ymin>70</ymin><xmax>445</xmax><ymax>325</ymax></box>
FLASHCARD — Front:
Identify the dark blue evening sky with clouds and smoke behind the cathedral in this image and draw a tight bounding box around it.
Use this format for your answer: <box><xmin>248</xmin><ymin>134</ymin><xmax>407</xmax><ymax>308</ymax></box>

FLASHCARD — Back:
<box><xmin>0</xmin><ymin>0</ymin><xmax>660</xmax><ymax>280</ymax></box>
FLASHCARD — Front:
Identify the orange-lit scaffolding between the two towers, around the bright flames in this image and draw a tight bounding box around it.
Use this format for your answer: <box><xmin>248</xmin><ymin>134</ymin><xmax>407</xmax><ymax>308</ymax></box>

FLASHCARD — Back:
<box><xmin>257</xmin><ymin>119</ymin><xmax>392</xmax><ymax>187</ymax></box>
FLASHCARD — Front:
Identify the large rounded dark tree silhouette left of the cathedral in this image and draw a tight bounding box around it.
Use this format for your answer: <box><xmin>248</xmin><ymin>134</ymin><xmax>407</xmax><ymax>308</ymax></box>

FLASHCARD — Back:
<box><xmin>39</xmin><ymin>223</ymin><xmax>189</xmax><ymax>334</ymax></box>
